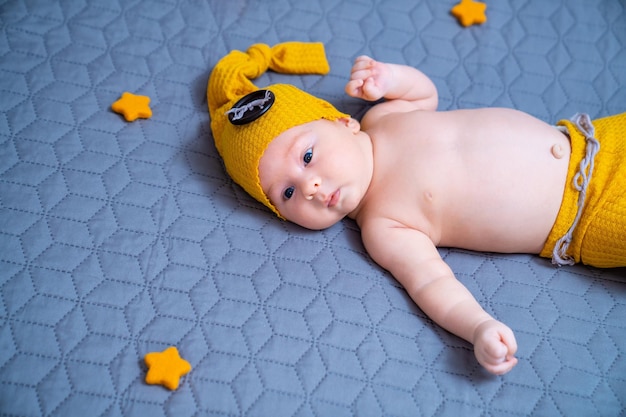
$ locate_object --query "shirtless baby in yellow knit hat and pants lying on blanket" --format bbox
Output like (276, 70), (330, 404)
(207, 43), (626, 374)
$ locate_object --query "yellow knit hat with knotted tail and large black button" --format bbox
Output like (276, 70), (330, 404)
(207, 42), (349, 218)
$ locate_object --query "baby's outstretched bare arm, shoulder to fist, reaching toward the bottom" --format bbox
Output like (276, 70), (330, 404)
(361, 224), (517, 375)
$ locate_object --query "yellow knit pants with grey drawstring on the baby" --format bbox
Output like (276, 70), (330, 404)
(540, 113), (626, 268)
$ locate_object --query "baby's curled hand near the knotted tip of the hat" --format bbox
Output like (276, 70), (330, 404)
(346, 55), (391, 101)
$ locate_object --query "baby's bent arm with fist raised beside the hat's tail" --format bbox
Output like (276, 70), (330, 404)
(346, 56), (438, 111)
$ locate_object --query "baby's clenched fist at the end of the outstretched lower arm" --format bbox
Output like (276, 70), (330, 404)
(474, 320), (517, 375)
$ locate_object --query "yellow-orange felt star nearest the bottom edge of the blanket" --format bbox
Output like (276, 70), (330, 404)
(144, 346), (191, 390)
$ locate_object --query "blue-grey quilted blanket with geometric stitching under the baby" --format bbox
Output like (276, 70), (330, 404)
(0, 0), (626, 417)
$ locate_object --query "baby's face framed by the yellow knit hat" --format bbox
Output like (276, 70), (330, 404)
(259, 119), (372, 230)
